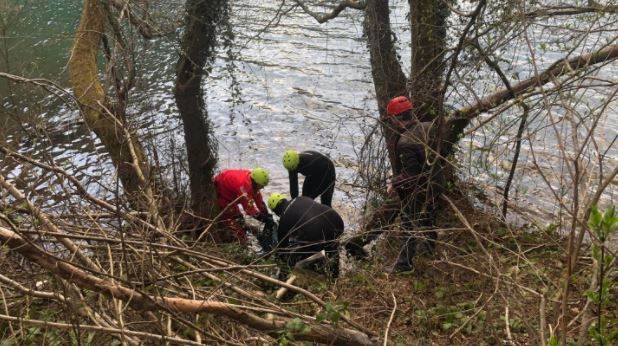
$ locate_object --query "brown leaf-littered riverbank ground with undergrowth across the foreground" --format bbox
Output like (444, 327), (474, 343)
(0, 189), (618, 345)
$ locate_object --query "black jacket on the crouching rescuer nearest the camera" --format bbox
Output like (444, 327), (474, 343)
(277, 196), (344, 249)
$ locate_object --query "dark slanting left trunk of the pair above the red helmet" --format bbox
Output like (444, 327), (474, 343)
(363, 0), (407, 173)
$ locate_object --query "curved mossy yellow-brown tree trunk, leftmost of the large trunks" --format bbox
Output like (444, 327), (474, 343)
(69, 0), (149, 199)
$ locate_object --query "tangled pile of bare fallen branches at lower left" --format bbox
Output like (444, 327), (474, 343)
(0, 148), (375, 344)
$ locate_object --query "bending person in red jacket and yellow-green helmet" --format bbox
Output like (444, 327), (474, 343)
(213, 167), (276, 243)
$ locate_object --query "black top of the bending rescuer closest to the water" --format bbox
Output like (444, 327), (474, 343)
(289, 150), (335, 198)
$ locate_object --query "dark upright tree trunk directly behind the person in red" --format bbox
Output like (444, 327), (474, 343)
(174, 0), (227, 222)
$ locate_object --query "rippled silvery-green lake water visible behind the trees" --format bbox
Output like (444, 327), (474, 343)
(0, 1), (618, 232)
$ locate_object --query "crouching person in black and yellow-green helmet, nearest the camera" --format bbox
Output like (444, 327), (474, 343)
(267, 193), (344, 277)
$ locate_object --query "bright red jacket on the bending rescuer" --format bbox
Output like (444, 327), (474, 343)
(214, 169), (268, 216)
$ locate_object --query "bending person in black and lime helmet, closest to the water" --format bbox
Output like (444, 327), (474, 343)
(283, 149), (337, 207)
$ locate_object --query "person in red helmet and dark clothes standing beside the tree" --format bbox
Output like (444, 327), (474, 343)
(346, 96), (441, 271)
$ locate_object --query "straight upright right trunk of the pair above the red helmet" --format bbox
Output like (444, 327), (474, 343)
(409, 0), (448, 121)
